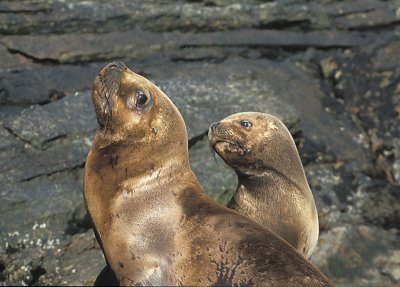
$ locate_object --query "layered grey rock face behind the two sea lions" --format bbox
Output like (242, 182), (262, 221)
(0, 0), (400, 286)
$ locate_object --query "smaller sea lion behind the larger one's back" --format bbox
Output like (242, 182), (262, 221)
(208, 112), (319, 258)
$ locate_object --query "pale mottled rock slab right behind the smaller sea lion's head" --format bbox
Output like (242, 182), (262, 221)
(154, 58), (365, 166)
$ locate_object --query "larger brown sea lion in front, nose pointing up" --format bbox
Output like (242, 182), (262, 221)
(84, 63), (332, 286)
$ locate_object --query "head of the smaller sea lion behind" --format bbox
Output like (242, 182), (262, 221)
(208, 112), (295, 176)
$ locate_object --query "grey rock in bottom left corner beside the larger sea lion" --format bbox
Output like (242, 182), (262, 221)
(1, 232), (105, 286)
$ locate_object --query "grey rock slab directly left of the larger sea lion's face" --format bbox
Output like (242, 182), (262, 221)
(4, 92), (97, 148)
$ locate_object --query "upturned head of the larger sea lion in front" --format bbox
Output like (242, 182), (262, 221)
(92, 62), (187, 150)
